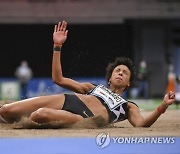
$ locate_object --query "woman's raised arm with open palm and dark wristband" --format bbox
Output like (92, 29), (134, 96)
(52, 21), (95, 94)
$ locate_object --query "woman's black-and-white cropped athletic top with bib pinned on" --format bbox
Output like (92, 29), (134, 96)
(88, 84), (135, 123)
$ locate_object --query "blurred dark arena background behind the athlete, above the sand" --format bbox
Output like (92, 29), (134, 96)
(0, 0), (180, 109)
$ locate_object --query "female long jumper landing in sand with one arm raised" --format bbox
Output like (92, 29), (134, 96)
(0, 21), (175, 127)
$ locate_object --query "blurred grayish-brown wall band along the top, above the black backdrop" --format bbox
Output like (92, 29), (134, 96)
(0, 0), (180, 24)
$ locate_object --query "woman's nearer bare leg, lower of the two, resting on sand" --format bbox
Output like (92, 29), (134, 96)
(29, 108), (84, 124)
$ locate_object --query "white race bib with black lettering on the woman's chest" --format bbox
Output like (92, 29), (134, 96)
(91, 85), (127, 111)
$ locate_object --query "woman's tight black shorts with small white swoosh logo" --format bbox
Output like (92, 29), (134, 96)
(62, 94), (94, 118)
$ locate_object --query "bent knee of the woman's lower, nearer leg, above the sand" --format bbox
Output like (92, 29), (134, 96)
(29, 108), (49, 123)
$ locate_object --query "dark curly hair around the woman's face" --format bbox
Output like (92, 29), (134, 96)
(106, 57), (135, 84)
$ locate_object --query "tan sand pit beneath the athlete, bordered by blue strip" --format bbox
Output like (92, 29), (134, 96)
(0, 110), (180, 138)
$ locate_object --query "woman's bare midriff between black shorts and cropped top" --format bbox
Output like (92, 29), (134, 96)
(76, 94), (108, 120)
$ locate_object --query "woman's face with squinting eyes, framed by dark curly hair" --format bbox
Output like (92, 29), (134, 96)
(109, 65), (131, 88)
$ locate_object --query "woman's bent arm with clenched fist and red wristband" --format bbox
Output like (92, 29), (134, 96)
(128, 92), (175, 127)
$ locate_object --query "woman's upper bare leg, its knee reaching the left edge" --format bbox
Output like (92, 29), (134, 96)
(0, 94), (65, 122)
